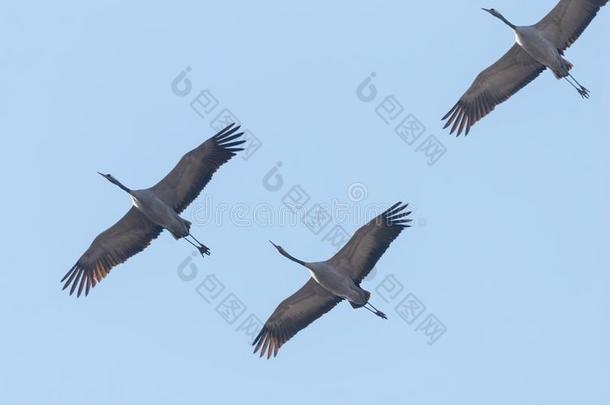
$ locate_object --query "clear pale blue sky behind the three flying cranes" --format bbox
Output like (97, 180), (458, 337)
(0, 0), (610, 405)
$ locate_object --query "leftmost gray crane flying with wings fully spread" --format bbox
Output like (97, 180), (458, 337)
(61, 124), (245, 297)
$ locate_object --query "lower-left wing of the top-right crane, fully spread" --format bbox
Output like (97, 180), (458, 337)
(442, 44), (546, 136)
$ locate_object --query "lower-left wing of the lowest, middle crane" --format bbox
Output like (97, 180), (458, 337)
(252, 278), (343, 358)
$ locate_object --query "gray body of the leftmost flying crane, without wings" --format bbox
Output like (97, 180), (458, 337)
(130, 189), (191, 239)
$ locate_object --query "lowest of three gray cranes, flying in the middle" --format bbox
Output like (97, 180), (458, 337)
(252, 202), (411, 358)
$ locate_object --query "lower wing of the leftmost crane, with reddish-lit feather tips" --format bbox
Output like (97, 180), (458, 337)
(61, 207), (163, 297)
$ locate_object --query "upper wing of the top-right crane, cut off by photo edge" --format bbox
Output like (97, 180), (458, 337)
(534, 0), (608, 52)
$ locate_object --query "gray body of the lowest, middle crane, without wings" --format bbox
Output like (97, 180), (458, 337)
(305, 262), (371, 307)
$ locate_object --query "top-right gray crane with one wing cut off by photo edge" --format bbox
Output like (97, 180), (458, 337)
(442, 0), (608, 136)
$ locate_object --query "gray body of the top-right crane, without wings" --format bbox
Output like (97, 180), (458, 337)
(514, 26), (572, 79)
